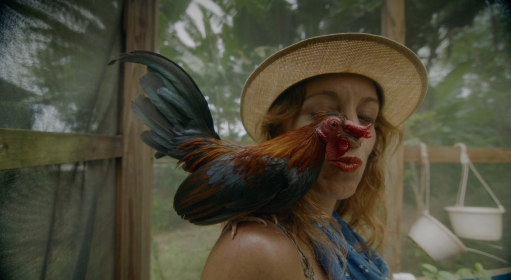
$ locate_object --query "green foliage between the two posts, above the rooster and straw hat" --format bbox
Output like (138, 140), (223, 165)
(158, 0), (381, 142)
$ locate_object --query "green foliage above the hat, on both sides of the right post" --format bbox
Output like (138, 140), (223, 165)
(159, 0), (511, 147)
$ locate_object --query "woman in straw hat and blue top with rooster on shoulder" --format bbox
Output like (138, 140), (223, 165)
(202, 34), (427, 280)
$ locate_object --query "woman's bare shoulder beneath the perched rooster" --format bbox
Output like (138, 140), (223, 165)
(201, 221), (304, 280)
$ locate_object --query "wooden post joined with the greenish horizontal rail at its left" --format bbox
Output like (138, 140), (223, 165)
(0, 0), (158, 279)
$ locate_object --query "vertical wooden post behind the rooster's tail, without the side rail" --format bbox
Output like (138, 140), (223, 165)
(116, 0), (158, 279)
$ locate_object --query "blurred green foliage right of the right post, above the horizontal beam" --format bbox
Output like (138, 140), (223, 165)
(405, 1), (511, 147)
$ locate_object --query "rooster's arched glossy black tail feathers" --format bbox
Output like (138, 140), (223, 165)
(109, 51), (220, 159)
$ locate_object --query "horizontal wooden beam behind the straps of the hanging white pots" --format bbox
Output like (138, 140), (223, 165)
(404, 146), (511, 163)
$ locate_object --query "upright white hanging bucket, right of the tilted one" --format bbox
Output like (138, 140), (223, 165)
(445, 206), (506, 241)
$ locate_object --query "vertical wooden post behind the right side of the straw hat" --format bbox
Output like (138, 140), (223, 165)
(382, 0), (405, 273)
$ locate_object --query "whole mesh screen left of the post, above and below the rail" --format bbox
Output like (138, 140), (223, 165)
(0, 1), (122, 279)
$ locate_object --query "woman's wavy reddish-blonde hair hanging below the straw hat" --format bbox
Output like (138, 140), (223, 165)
(260, 74), (402, 276)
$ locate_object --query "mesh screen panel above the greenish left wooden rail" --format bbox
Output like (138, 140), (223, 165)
(0, 1), (121, 135)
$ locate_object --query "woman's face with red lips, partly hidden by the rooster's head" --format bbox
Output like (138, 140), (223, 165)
(282, 74), (380, 205)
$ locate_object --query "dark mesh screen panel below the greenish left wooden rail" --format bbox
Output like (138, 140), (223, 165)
(0, 160), (116, 279)
